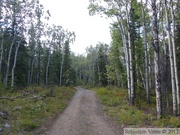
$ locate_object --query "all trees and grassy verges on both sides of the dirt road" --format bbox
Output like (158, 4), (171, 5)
(0, 0), (180, 132)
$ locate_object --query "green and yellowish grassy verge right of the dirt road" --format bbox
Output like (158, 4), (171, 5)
(93, 87), (180, 128)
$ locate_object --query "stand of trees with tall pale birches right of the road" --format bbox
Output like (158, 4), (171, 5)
(71, 0), (180, 118)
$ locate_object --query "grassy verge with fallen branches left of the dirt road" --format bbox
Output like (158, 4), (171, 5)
(0, 87), (76, 135)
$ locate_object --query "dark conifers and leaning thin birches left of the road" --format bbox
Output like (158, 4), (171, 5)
(0, 0), (75, 90)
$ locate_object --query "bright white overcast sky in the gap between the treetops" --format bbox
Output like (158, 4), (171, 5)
(40, 0), (111, 54)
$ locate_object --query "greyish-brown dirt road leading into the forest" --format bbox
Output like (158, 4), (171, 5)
(48, 87), (121, 135)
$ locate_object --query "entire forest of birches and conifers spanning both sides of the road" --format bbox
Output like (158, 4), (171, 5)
(0, 0), (180, 133)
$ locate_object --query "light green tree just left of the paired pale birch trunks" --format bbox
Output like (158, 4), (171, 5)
(106, 26), (126, 87)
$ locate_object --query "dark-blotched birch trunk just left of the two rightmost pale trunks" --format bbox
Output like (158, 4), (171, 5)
(151, 0), (162, 119)
